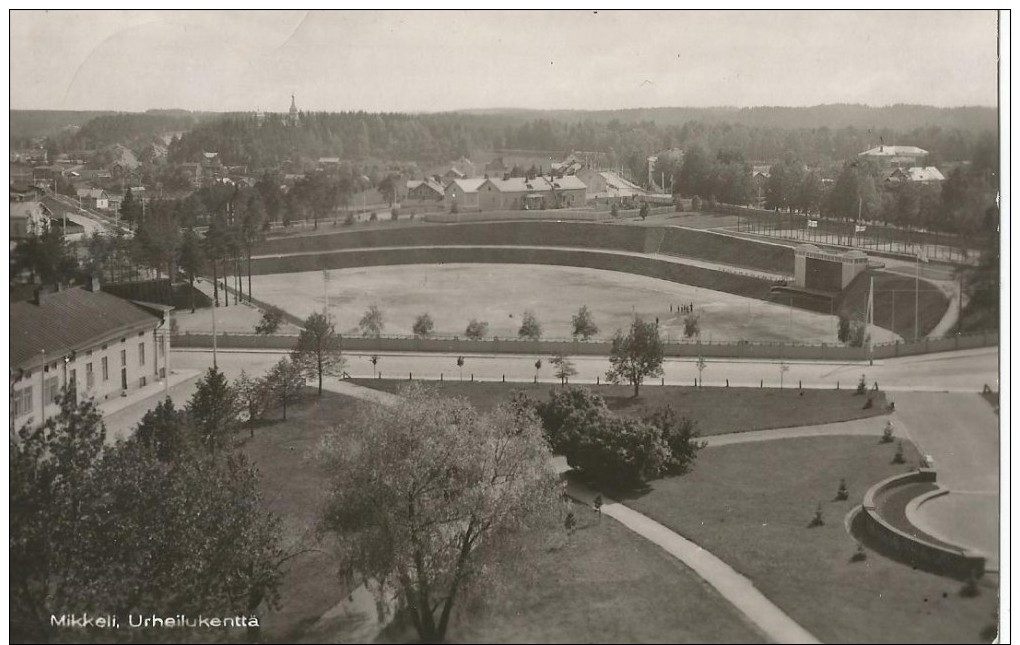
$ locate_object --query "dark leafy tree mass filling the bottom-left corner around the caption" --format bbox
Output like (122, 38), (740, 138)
(9, 385), (286, 642)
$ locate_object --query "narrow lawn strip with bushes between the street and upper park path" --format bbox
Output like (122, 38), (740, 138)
(354, 379), (885, 437)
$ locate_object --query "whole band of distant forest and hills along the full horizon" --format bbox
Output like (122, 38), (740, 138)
(11, 105), (998, 177)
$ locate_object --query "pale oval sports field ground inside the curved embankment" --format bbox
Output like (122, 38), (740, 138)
(253, 263), (901, 343)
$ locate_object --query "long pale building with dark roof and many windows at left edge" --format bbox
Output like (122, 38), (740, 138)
(9, 281), (171, 428)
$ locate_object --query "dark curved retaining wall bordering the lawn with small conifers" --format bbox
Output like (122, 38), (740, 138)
(861, 468), (985, 579)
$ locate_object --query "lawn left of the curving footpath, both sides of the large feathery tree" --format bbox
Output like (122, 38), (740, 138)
(236, 388), (761, 642)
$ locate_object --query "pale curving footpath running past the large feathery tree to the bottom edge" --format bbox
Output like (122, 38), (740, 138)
(322, 378), (821, 643)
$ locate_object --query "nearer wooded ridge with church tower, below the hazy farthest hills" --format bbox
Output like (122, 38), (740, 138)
(150, 112), (993, 182)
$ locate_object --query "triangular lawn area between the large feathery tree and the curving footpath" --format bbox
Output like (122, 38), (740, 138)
(449, 508), (764, 643)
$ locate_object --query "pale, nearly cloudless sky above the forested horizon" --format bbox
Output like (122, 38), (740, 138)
(10, 10), (998, 112)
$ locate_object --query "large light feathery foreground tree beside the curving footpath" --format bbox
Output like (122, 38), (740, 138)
(321, 385), (558, 643)
